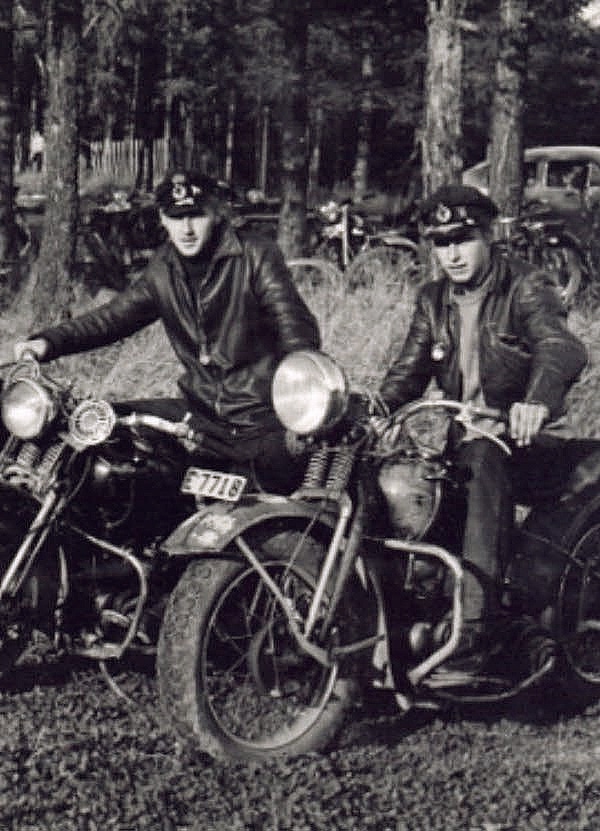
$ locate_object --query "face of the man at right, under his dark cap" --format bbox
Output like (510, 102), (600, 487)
(431, 228), (490, 285)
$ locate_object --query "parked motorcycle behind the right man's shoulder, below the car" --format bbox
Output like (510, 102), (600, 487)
(499, 205), (595, 309)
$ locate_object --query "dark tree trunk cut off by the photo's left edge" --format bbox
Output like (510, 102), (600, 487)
(0, 2), (19, 306)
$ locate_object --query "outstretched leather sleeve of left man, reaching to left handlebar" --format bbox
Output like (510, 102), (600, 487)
(31, 277), (159, 361)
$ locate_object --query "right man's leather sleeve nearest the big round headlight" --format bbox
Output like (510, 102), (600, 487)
(379, 284), (433, 410)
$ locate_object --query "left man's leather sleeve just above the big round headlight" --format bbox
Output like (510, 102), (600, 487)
(253, 244), (321, 356)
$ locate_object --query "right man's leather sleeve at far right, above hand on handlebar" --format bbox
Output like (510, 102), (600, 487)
(517, 271), (587, 418)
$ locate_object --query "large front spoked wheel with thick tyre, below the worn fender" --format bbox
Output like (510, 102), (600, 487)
(158, 532), (354, 760)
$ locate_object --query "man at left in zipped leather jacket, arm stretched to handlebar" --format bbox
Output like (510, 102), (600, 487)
(15, 170), (320, 487)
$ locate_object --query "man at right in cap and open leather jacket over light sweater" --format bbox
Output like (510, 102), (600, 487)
(380, 185), (587, 668)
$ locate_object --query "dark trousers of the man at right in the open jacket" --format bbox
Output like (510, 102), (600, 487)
(455, 434), (600, 620)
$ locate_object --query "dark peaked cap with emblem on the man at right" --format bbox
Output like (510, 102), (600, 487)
(419, 185), (498, 236)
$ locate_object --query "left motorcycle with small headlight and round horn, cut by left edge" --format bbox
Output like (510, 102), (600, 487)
(0, 355), (258, 678)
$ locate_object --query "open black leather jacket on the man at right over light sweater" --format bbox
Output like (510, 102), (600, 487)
(380, 252), (587, 418)
